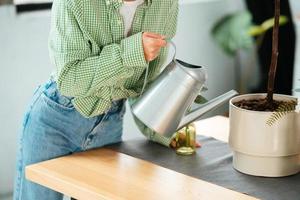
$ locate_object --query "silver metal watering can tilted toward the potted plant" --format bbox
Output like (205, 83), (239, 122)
(131, 42), (237, 137)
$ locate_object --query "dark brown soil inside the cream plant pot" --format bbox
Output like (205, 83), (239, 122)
(233, 98), (297, 112)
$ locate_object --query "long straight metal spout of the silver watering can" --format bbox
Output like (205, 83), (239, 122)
(177, 90), (238, 130)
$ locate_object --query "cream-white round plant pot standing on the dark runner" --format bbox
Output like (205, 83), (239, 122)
(229, 94), (300, 177)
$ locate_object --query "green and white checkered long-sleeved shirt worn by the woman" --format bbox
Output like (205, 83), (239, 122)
(49, 0), (178, 147)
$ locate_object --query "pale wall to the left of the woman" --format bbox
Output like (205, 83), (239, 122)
(0, 6), (51, 196)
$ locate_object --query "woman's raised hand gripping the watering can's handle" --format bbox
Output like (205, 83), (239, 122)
(143, 32), (167, 62)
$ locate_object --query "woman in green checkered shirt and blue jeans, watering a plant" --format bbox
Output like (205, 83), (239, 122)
(14, 0), (178, 200)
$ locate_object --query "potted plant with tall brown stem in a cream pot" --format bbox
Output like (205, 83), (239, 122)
(229, 0), (300, 177)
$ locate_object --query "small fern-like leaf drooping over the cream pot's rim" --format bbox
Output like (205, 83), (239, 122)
(267, 101), (297, 126)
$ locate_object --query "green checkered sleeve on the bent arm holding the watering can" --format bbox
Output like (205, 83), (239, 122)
(49, 0), (148, 97)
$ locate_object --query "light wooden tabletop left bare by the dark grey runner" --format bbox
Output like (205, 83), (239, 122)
(26, 117), (255, 200)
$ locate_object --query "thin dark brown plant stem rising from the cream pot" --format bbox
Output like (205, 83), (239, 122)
(267, 0), (280, 107)
